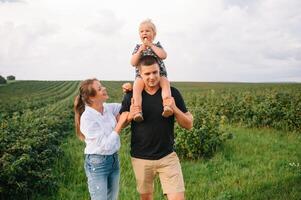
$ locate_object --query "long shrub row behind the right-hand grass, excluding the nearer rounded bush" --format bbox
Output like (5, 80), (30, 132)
(183, 88), (301, 132)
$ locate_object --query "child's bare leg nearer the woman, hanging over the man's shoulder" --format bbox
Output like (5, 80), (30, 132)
(133, 77), (144, 122)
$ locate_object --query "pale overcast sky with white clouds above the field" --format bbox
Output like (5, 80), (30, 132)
(0, 0), (301, 82)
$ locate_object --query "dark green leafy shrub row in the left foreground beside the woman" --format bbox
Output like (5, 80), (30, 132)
(0, 82), (78, 199)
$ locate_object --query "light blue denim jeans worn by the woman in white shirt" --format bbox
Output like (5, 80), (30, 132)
(85, 152), (120, 200)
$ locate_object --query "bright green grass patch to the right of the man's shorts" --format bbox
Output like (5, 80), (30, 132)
(182, 128), (301, 200)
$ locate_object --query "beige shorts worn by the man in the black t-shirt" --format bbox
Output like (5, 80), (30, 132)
(131, 152), (185, 194)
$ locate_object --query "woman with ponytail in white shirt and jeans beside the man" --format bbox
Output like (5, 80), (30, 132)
(74, 79), (128, 200)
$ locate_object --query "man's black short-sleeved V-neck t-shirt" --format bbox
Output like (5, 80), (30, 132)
(120, 87), (187, 160)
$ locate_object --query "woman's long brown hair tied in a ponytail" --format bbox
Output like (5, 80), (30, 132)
(73, 78), (98, 140)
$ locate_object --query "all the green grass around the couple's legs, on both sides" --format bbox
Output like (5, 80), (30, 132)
(35, 127), (301, 200)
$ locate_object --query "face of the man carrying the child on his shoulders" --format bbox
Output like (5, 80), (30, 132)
(140, 63), (160, 87)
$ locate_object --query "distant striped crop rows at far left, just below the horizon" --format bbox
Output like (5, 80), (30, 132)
(0, 81), (77, 119)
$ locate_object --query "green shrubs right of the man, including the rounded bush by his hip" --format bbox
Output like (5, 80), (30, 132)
(175, 84), (301, 159)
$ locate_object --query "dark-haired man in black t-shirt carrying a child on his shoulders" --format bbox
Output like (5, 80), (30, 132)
(120, 56), (193, 200)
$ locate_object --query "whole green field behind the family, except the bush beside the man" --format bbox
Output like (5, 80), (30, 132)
(0, 81), (301, 200)
